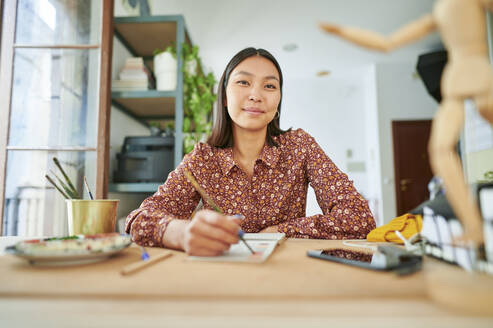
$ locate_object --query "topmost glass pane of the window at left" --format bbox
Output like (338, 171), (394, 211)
(15, 0), (102, 45)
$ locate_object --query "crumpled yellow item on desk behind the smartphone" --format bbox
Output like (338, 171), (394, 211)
(366, 213), (423, 244)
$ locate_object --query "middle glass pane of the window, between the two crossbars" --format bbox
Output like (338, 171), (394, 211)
(9, 49), (99, 147)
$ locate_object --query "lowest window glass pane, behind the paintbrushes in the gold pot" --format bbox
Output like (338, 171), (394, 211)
(3, 151), (96, 237)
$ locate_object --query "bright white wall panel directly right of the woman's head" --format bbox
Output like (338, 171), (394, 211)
(281, 68), (367, 215)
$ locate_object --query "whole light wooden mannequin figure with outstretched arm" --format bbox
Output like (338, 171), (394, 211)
(320, 0), (493, 244)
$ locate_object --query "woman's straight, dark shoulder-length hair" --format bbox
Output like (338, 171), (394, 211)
(207, 47), (291, 148)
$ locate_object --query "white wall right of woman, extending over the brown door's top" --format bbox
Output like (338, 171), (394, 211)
(281, 61), (437, 225)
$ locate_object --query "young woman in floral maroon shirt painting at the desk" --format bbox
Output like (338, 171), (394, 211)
(126, 48), (375, 256)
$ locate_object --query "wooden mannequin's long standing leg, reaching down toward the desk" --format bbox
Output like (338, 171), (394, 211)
(428, 98), (483, 244)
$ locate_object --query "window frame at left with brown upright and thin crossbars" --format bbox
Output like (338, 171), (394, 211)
(0, 0), (114, 236)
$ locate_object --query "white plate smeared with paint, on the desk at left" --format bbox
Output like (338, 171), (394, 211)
(5, 234), (132, 266)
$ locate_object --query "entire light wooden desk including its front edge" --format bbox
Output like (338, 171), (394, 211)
(0, 239), (493, 327)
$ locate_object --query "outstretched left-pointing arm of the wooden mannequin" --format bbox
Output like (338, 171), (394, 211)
(320, 14), (436, 52)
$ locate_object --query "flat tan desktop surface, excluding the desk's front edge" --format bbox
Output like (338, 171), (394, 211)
(0, 239), (426, 299)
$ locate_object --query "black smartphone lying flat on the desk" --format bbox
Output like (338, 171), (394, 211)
(307, 245), (421, 274)
